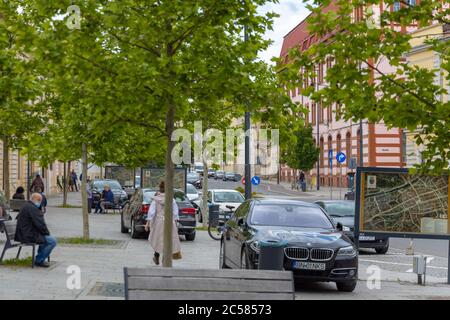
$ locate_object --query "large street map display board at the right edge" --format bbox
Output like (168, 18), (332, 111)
(356, 168), (450, 238)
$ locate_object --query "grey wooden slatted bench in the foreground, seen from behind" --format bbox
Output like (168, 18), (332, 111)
(124, 268), (295, 300)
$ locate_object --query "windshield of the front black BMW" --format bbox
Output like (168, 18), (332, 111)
(250, 204), (333, 229)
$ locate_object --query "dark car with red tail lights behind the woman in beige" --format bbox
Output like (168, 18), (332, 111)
(120, 189), (197, 241)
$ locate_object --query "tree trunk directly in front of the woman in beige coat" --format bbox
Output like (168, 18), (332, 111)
(163, 102), (175, 268)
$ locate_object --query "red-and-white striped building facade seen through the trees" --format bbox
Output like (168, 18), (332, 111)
(280, 3), (417, 187)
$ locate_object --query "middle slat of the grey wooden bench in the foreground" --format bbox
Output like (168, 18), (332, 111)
(128, 277), (293, 293)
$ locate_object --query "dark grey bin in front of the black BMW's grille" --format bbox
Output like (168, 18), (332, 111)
(258, 240), (287, 270)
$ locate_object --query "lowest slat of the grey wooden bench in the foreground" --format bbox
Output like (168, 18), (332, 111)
(129, 290), (294, 301)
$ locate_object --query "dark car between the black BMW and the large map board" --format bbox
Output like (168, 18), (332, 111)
(315, 200), (389, 254)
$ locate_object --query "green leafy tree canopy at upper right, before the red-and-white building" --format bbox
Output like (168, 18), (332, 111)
(280, 0), (450, 173)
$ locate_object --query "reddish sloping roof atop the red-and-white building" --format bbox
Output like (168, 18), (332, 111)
(280, 1), (337, 58)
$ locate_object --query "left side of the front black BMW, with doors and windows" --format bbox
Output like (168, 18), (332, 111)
(225, 201), (250, 268)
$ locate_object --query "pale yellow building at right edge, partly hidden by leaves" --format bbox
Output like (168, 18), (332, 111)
(403, 24), (450, 167)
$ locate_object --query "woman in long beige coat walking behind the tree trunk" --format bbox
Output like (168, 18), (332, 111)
(145, 181), (181, 265)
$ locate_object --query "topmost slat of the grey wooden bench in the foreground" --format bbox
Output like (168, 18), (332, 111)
(127, 268), (292, 280)
